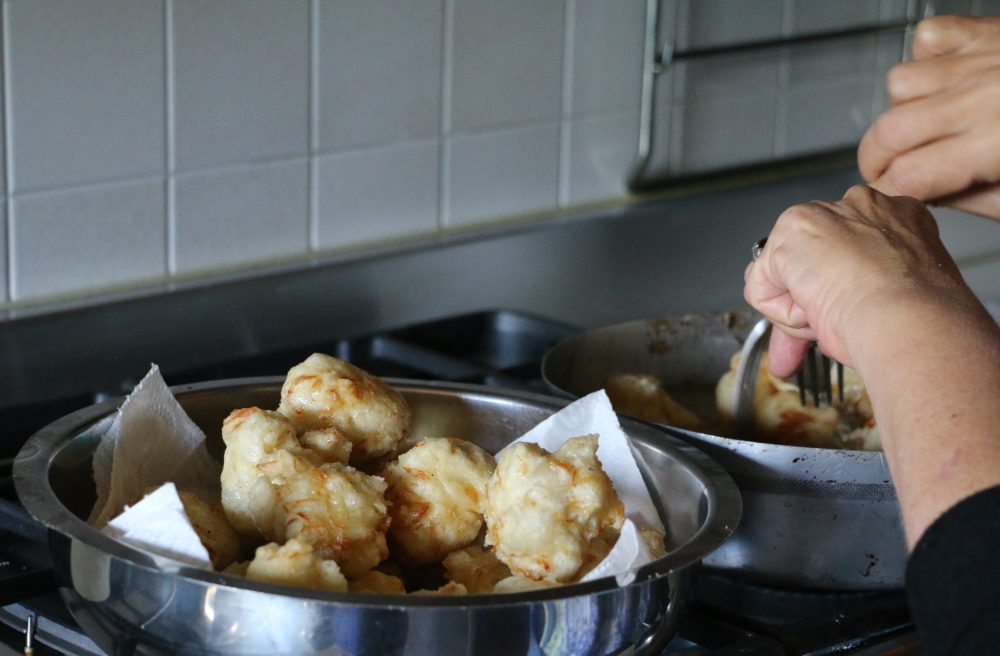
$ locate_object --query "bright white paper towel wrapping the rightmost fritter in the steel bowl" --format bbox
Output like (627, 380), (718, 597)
(508, 390), (663, 585)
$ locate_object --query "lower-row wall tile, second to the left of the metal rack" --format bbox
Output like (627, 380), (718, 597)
(443, 124), (559, 226)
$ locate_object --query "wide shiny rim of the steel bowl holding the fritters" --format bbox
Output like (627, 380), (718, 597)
(13, 376), (742, 608)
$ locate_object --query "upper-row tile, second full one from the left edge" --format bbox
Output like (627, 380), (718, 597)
(170, 0), (309, 171)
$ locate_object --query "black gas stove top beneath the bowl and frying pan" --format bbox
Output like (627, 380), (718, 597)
(0, 310), (919, 655)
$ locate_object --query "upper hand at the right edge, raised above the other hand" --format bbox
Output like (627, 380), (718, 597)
(858, 16), (1000, 219)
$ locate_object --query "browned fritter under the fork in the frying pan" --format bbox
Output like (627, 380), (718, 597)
(715, 353), (877, 448)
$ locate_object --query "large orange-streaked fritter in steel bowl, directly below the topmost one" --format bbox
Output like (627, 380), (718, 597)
(260, 451), (389, 576)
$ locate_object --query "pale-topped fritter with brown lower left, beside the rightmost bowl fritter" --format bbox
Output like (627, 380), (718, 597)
(381, 437), (496, 565)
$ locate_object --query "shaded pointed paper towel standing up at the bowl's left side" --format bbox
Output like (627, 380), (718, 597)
(87, 365), (222, 528)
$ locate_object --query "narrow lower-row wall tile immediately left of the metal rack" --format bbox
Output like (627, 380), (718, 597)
(566, 114), (639, 204)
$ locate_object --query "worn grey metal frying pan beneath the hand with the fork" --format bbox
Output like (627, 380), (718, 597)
(542, 311), (906, 590)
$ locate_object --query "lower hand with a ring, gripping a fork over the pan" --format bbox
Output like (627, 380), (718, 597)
(744, 185), (974, 377)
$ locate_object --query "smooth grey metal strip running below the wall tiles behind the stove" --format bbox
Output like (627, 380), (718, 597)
(0, 166), (858, 407)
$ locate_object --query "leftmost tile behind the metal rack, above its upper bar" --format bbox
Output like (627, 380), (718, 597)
(674, 0), (782, 50)
